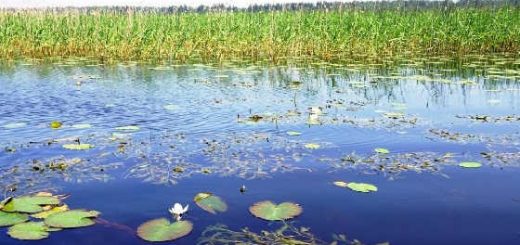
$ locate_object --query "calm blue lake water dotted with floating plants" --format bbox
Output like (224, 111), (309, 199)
(0, 56), (520, 244)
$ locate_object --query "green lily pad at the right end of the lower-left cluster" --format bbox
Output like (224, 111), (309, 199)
(44, 209), (100, 228)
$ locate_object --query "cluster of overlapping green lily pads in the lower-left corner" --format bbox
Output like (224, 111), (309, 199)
(0, 192), (100, 240)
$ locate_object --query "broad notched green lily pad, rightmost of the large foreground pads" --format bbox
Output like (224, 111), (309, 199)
(249, 201), (303, 221)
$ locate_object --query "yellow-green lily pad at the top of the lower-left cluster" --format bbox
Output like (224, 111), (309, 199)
(2, 196), (60, 213)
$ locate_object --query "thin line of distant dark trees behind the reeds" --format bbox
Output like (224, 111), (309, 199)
(3, 0), (520, 13)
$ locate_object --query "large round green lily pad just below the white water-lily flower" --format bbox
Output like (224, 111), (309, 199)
(137, 218), (193, 242)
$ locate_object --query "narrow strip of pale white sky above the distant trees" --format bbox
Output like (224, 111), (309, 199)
(0, 0), (366, 8)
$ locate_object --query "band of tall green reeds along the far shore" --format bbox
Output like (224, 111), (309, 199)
(0, 1), (520, 63)
